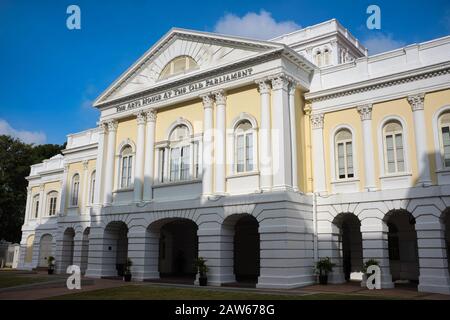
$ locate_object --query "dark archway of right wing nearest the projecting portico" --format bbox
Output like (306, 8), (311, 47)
(333, 213), (363, 281)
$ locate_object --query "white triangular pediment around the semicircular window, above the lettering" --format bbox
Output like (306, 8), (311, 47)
(94, 29), (282, 106)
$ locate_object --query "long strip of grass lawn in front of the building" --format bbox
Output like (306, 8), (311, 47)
(47, 285), (384, 300)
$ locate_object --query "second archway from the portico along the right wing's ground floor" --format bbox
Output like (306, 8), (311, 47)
(386, 210), (419, 285)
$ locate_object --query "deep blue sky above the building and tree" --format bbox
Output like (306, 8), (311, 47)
(0, 0), (450, 143)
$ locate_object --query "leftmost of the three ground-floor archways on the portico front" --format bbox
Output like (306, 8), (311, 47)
(103, 221), (128, 277)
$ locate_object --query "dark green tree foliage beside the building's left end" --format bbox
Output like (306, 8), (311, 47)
(0, 135), (65, 242)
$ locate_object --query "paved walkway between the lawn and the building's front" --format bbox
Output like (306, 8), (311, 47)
(0, 271), (450, 300)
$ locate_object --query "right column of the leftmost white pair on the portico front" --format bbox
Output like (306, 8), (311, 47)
(103, 120), (117, 206)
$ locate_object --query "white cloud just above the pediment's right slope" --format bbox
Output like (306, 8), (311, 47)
(214, 10), (301, 40)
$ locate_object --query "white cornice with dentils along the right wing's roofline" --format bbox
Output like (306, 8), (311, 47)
(305, 62), (450, 103)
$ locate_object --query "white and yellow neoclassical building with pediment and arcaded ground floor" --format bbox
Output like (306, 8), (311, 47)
(20, 20), (450, 294)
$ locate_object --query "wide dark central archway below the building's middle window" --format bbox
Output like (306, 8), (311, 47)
(157, 219), (198, 282)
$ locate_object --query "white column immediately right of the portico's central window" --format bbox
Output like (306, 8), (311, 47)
(201, 95), (213, 195)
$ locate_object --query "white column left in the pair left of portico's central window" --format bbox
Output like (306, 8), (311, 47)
(133, 111), (145, 202)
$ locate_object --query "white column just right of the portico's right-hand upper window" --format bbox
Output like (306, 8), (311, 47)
(256, 80), (272, 191)
